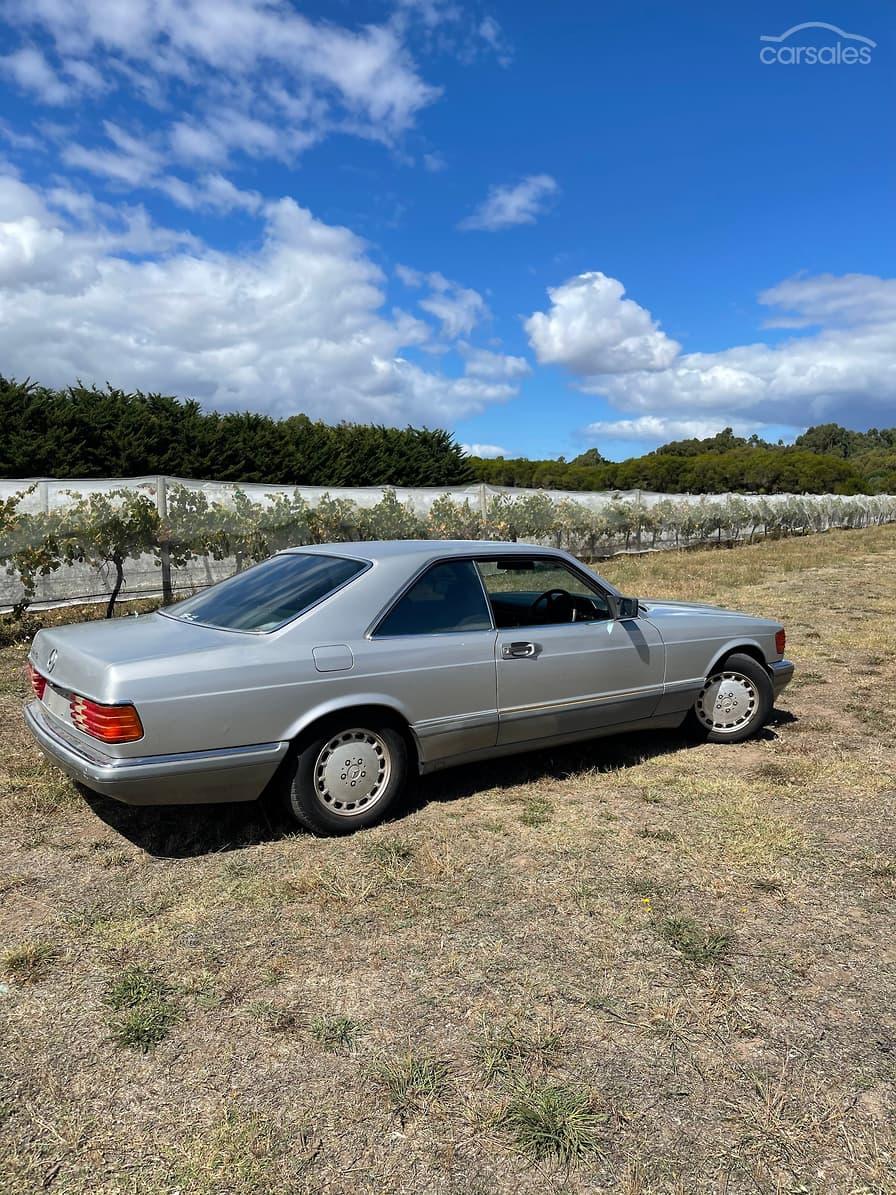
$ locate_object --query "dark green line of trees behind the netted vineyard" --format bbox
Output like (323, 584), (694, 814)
(0, 376), (896, 495)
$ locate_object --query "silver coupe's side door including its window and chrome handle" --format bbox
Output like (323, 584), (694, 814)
(478, 557), (665, 746)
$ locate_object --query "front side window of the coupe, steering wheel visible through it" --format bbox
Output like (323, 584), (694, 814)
(478, 557), (613, 629)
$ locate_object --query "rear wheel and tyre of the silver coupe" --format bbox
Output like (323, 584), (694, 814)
(286, 716), (407, 837)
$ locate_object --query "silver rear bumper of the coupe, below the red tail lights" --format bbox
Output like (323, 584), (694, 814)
(25, 701), (289, 805)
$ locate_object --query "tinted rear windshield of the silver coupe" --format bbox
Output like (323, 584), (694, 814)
(164, 552), (367, 631)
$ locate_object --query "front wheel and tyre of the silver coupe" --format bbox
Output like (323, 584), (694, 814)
(689, 652), (774, 743)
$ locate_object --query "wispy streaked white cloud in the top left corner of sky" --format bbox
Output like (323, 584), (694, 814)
(2, 0), (440, 195)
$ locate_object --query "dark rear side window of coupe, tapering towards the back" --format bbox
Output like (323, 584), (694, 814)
(374, 560), (491, 638)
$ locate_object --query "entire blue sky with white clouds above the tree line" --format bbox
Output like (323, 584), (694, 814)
(0, 0), (896, 458)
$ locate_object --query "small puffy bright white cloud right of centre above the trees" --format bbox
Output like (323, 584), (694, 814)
(526, 271), (679, 376)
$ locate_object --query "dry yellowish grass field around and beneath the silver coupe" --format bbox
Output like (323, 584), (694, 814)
(0, 527), (896, 1195)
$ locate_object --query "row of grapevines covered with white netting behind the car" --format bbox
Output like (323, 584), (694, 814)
(0, 477), (896, 609)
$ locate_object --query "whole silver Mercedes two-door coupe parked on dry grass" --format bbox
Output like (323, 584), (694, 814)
(25, 540), (793, 834)
